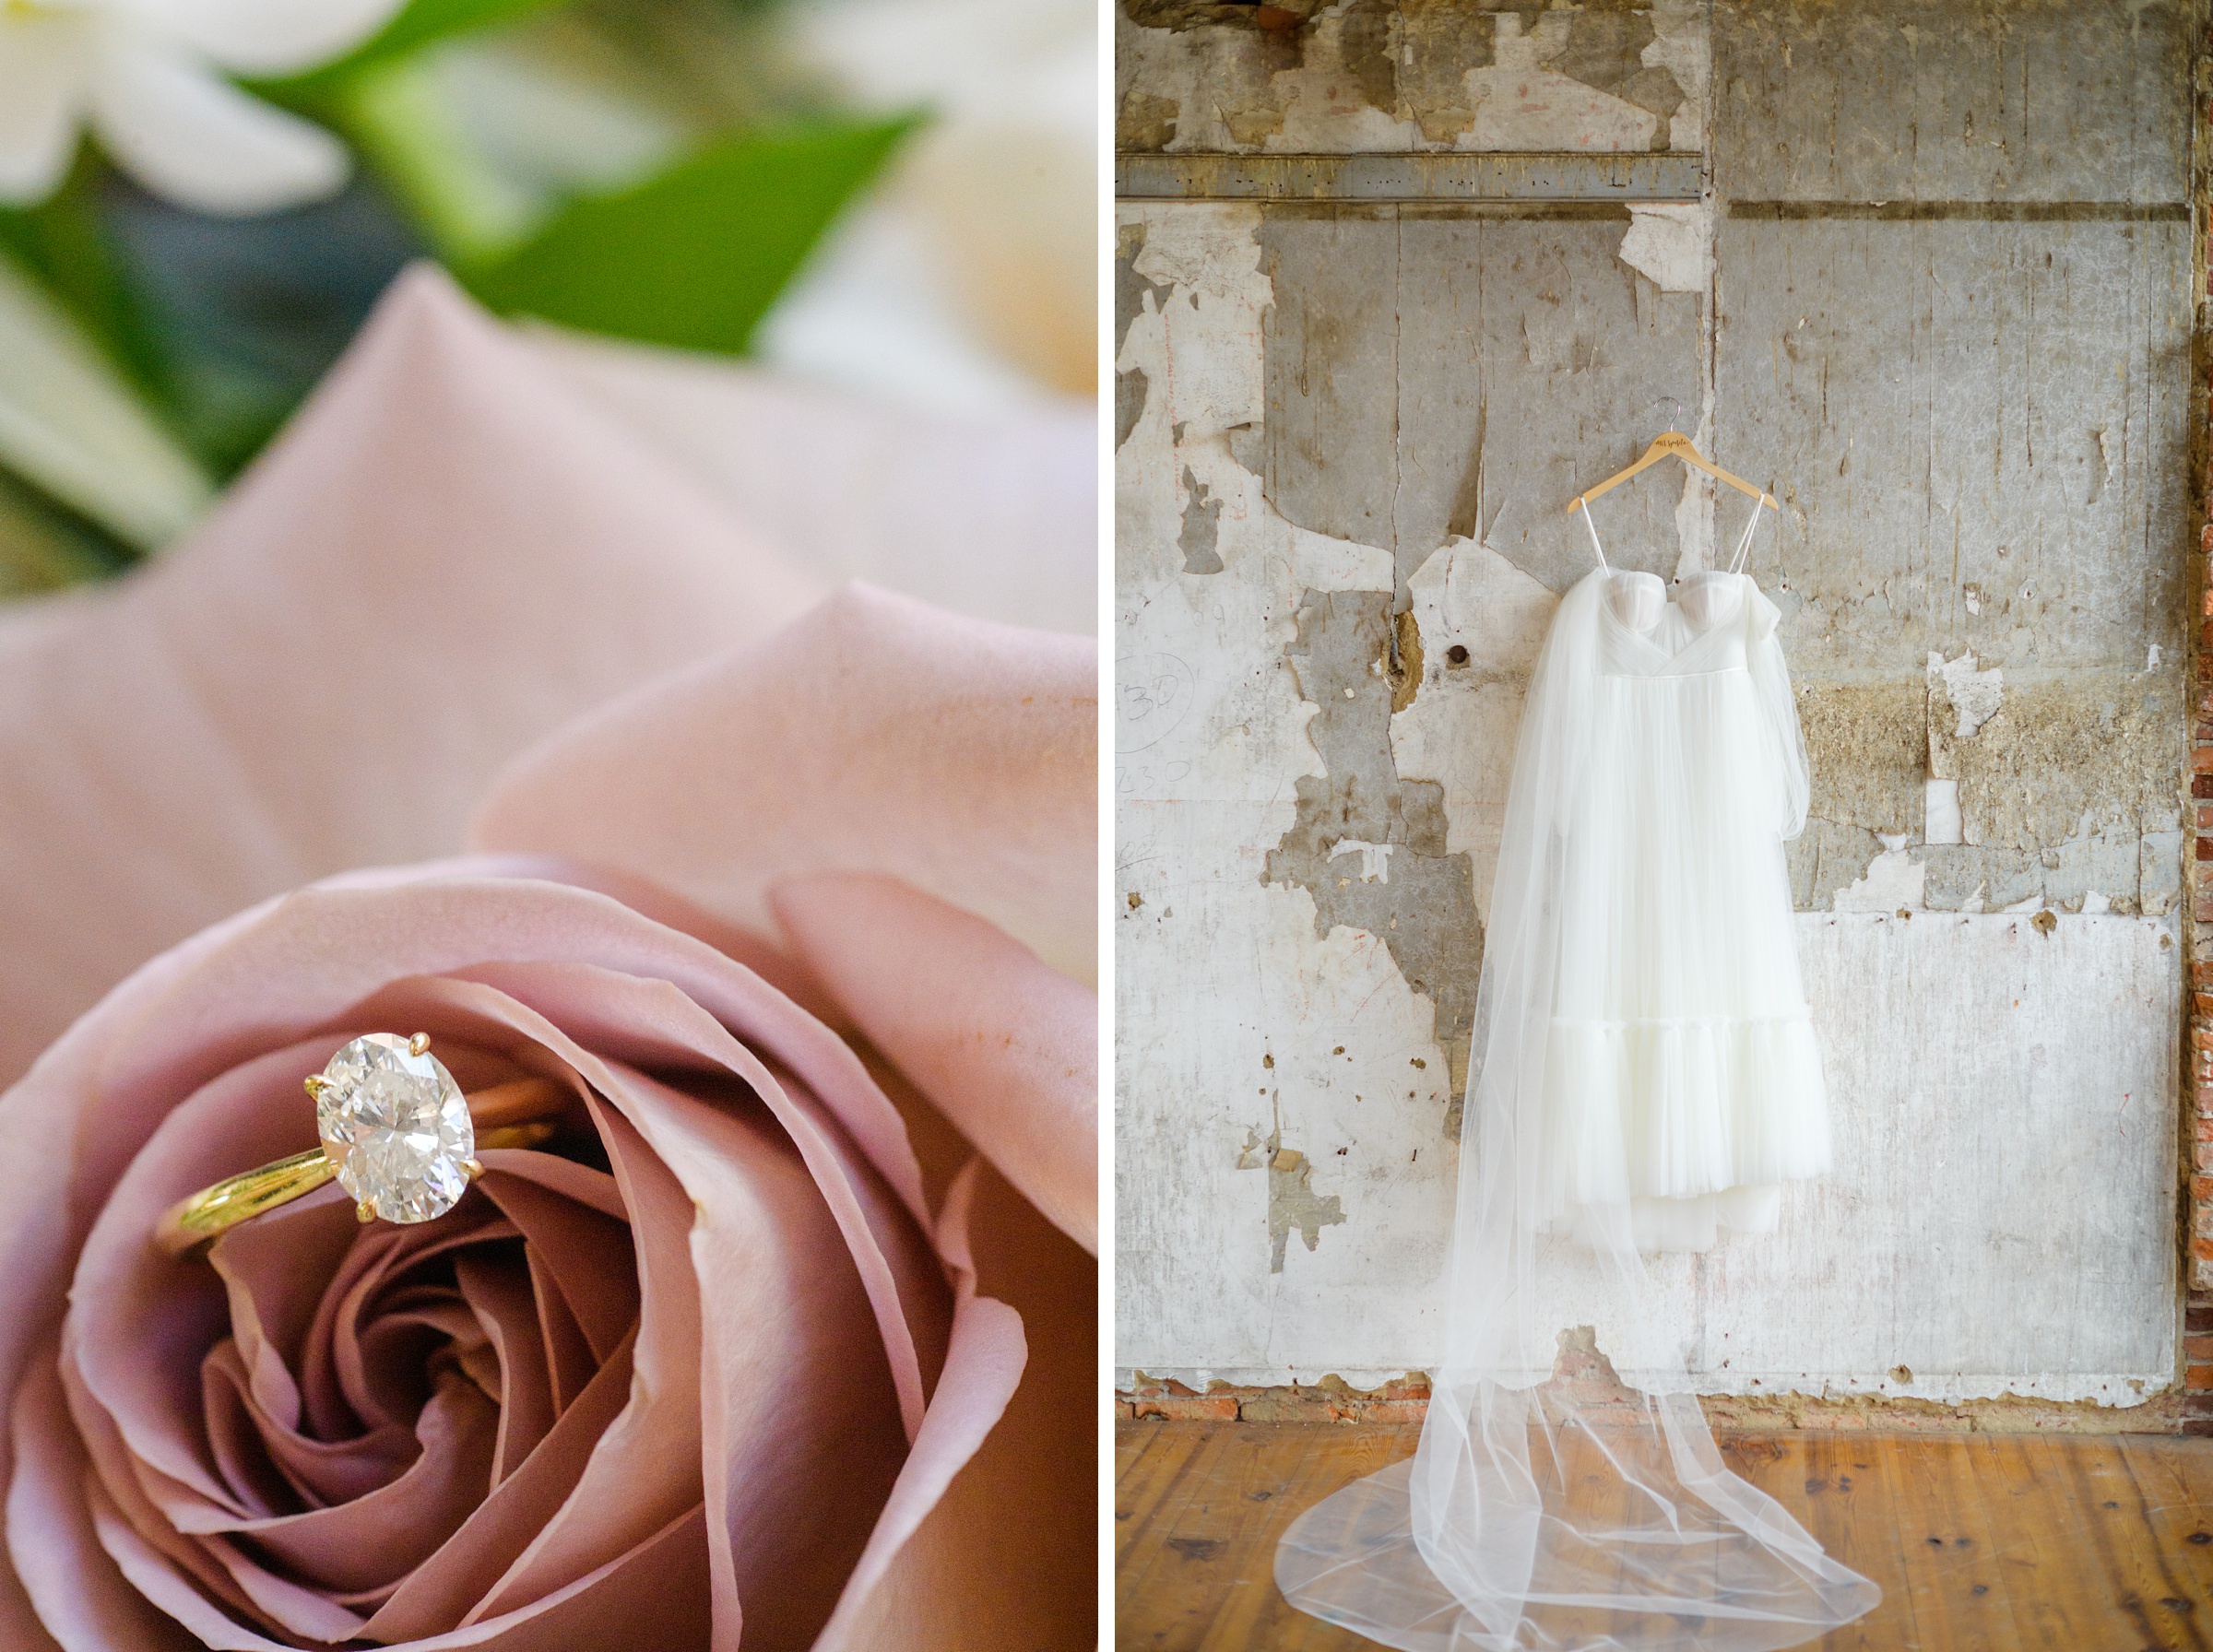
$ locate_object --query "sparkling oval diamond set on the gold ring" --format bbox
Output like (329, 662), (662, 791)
(314, 1032), (476, 1221)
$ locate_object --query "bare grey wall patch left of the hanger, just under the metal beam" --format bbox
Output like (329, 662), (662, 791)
(1249, 206), (1699, 606)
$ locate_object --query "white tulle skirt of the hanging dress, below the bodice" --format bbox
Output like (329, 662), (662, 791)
(1538, 667), (1830, 1249)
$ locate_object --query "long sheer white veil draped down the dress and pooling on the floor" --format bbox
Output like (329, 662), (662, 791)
(1277, 572), (1881, 1652)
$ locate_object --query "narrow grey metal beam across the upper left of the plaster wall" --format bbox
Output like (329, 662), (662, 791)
(1116, 153), (1704, 201)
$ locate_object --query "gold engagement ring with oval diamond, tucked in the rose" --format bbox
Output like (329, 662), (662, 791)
(153, 1032), (566, 1257)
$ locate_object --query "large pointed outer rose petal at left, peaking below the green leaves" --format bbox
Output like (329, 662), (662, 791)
(0, 267), (819, 1081)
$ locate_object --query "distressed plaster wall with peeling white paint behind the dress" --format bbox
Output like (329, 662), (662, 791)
(1118, 0), (2195, 1404)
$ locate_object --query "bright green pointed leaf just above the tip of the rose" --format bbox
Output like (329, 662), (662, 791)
(463, 117), (918, 356)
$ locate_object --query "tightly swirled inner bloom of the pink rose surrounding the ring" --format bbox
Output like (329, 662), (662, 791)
(0, 869), (1023, 1647)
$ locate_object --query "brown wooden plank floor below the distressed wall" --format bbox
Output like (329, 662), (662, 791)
(1113, 1422), (2213, 1652)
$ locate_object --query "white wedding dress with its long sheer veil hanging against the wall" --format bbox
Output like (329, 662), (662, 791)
(1274, 506), (1881, 1652)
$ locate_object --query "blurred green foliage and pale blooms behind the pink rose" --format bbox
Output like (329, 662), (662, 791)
(0, 0), (1095, 595)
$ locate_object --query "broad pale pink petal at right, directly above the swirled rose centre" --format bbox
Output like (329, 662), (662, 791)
(474, 586), (1097, 980)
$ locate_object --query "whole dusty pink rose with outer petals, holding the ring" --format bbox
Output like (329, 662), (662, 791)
(0, 277), (1097, 1652)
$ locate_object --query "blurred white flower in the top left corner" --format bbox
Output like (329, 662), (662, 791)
(0, 0), (400, 215)
